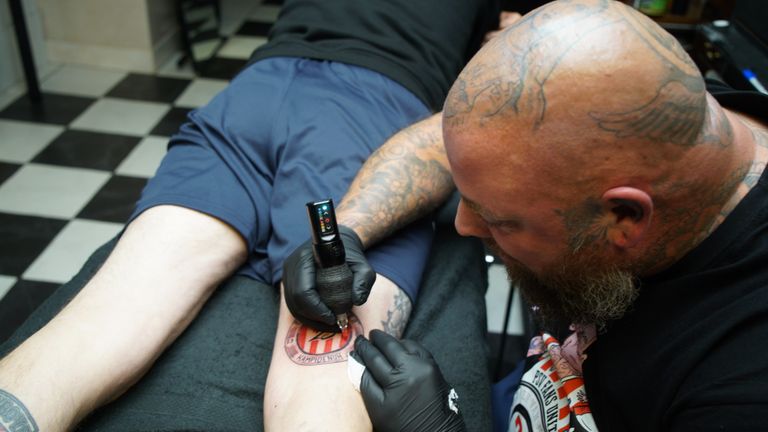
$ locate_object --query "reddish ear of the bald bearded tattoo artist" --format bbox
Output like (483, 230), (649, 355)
(601, 186), (653, 249)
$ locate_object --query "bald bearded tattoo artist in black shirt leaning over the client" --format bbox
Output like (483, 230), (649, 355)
(286, 0), (768, 431)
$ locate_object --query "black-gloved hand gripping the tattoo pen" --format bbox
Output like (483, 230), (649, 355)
(283, 225), (376, 332)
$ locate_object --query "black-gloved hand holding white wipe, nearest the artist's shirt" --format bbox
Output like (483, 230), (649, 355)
(353, 330), (466, 432)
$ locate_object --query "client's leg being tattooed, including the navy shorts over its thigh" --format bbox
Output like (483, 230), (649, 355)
(264, 61), (432, 431)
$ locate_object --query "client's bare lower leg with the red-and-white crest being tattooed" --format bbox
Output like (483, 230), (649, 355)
(264, 275), (411, 432)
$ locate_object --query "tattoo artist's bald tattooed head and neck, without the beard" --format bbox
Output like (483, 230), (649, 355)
(443, 0), (766, 317)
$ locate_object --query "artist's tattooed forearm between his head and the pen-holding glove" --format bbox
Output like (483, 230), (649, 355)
(337, 113), (453, 247)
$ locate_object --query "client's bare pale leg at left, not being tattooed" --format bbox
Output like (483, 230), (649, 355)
(0, 206), (246, 431)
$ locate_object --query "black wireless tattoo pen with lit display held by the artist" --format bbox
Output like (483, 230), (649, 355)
(307, 199), (353, 331)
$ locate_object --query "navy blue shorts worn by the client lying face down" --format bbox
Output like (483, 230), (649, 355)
(131, 57), (432, 300)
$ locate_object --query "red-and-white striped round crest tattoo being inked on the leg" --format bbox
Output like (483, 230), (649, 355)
(285, 314), (363, 366)
